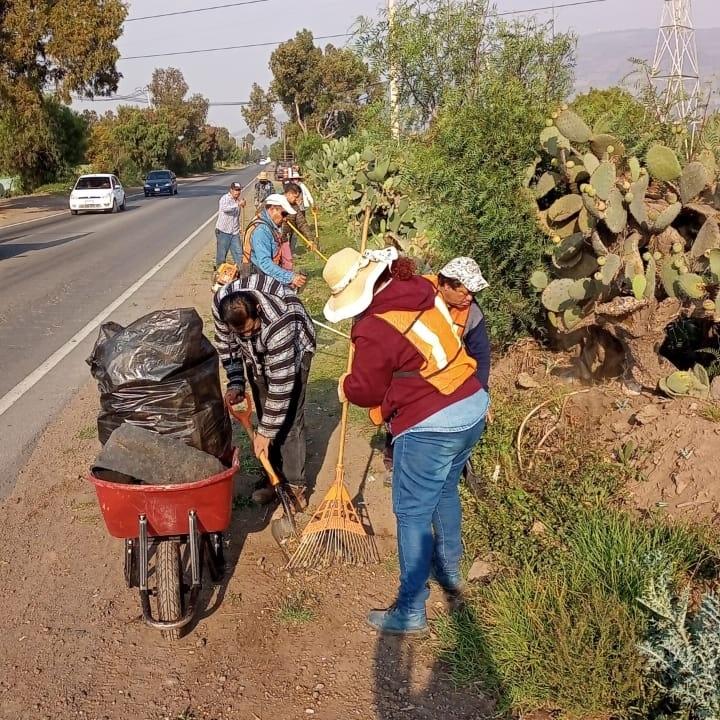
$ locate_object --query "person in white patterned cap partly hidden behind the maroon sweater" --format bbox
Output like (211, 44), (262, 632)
(383, 257), (490, 473)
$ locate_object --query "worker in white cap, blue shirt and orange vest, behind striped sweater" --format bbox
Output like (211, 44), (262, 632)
(242, 193), (307, 289)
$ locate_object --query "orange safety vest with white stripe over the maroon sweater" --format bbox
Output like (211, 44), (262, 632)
(370, 295), (477, 425)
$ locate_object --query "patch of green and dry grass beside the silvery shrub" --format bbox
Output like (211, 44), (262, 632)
(434, 391), (718, 718)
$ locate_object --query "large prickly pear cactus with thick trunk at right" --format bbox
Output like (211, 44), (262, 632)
(525, 106), (720, 388)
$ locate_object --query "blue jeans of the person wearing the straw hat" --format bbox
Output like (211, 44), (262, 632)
(392, 417), (485, 611)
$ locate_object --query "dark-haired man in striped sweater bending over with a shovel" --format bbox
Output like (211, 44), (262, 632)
(213, 273), (316, 505)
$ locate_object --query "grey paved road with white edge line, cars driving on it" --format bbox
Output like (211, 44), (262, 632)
(0, 167), (257, 497)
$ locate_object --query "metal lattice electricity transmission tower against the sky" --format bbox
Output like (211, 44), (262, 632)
(651, 0), (701, 128)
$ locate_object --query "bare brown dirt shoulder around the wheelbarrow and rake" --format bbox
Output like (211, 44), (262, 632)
(0, 240), (490, 720)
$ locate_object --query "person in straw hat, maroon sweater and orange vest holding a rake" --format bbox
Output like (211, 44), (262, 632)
(323, 247), (488, 634)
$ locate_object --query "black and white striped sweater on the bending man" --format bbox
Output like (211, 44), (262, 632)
(213, 274), (315, 439)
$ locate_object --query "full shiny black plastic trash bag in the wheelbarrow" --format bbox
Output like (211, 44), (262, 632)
(87, 308), (232, 462)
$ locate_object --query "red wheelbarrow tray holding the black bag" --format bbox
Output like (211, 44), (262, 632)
(88, 462), (237, 538)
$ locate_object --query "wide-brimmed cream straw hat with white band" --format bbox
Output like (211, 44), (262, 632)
(323, 247), (398, 322)
